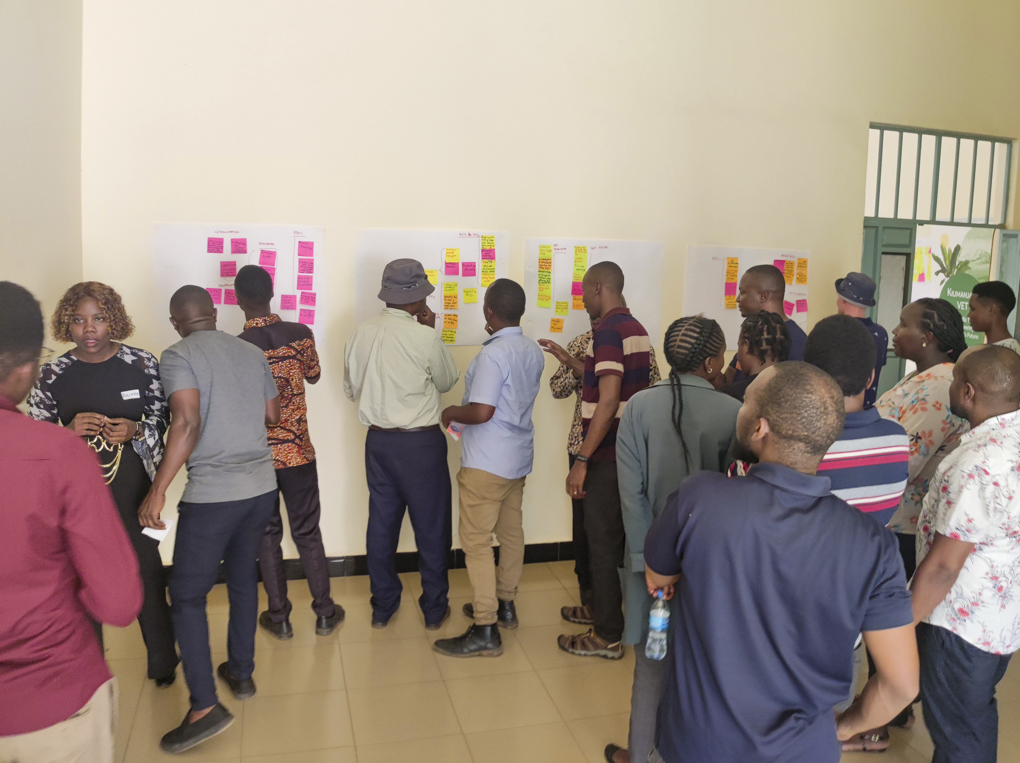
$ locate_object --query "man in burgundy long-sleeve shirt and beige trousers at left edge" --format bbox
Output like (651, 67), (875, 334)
(0, 282), (142, 763)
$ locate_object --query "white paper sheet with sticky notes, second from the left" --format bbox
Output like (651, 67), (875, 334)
(354, 230), (510, 345)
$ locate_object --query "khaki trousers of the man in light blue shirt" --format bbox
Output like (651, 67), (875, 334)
(457, 468), (526, 625)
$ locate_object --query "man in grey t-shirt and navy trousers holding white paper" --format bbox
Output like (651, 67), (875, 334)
(139, 286), (279, 753)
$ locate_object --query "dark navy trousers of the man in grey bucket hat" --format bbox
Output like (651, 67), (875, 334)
(365, 426), (453, 623)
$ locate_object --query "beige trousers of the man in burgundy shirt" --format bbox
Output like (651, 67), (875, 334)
(0, 678), (117, 763)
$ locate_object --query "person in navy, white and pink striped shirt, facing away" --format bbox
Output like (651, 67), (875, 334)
(804, 315), (910, 527)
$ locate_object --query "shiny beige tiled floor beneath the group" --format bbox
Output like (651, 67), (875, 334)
(106, 562), (1020, 763)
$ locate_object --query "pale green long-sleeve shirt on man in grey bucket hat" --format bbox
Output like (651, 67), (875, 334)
(344, 307), (458, 429)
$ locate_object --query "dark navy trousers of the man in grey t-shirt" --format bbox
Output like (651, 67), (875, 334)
(169, 491), (276, 710)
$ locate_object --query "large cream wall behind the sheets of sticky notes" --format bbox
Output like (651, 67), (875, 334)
(83, 0), (1020, 554)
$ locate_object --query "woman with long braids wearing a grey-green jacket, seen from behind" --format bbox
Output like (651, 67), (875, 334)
(606, 316), (741, 763)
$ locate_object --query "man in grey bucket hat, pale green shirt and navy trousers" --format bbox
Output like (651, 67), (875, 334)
(344, 259), (458, 630)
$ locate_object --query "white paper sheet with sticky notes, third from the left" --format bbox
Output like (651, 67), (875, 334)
(521, 239), (662, 347)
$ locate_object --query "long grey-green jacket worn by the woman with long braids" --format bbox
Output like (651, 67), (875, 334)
(616, 374), (741, 645)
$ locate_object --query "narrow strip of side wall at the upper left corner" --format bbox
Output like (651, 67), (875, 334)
(0, 0), (82, 316)
